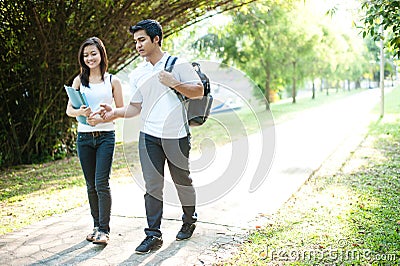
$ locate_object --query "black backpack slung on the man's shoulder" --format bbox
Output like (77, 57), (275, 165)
(164, 56), (213, 133)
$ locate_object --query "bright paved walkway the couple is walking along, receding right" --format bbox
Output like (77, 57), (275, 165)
(0, 90), (379, 265)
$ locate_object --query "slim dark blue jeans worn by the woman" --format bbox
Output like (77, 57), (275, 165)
(77, 131), (115, 233)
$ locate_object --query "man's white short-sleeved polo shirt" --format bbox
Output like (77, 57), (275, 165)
(129, 53), (201, 139)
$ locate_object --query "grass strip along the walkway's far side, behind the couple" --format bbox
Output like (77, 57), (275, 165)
(0, 87), (374, 235)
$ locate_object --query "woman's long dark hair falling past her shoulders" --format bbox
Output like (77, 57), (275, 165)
(78, 37), (108, 87)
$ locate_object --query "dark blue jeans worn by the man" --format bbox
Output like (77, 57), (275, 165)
(139, 132), (197, 236)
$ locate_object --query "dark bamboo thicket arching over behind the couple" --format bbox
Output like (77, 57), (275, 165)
(0, 0), (254, 166)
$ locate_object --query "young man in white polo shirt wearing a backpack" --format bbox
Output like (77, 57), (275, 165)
(97, 20), (203, 254)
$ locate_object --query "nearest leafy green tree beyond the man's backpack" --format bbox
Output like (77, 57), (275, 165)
(194, 1), (298, 108)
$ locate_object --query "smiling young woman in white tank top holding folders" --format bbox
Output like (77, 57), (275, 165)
(66, 37), (123, 245)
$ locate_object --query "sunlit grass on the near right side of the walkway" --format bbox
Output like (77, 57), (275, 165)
(218, 88), (400, 265)
